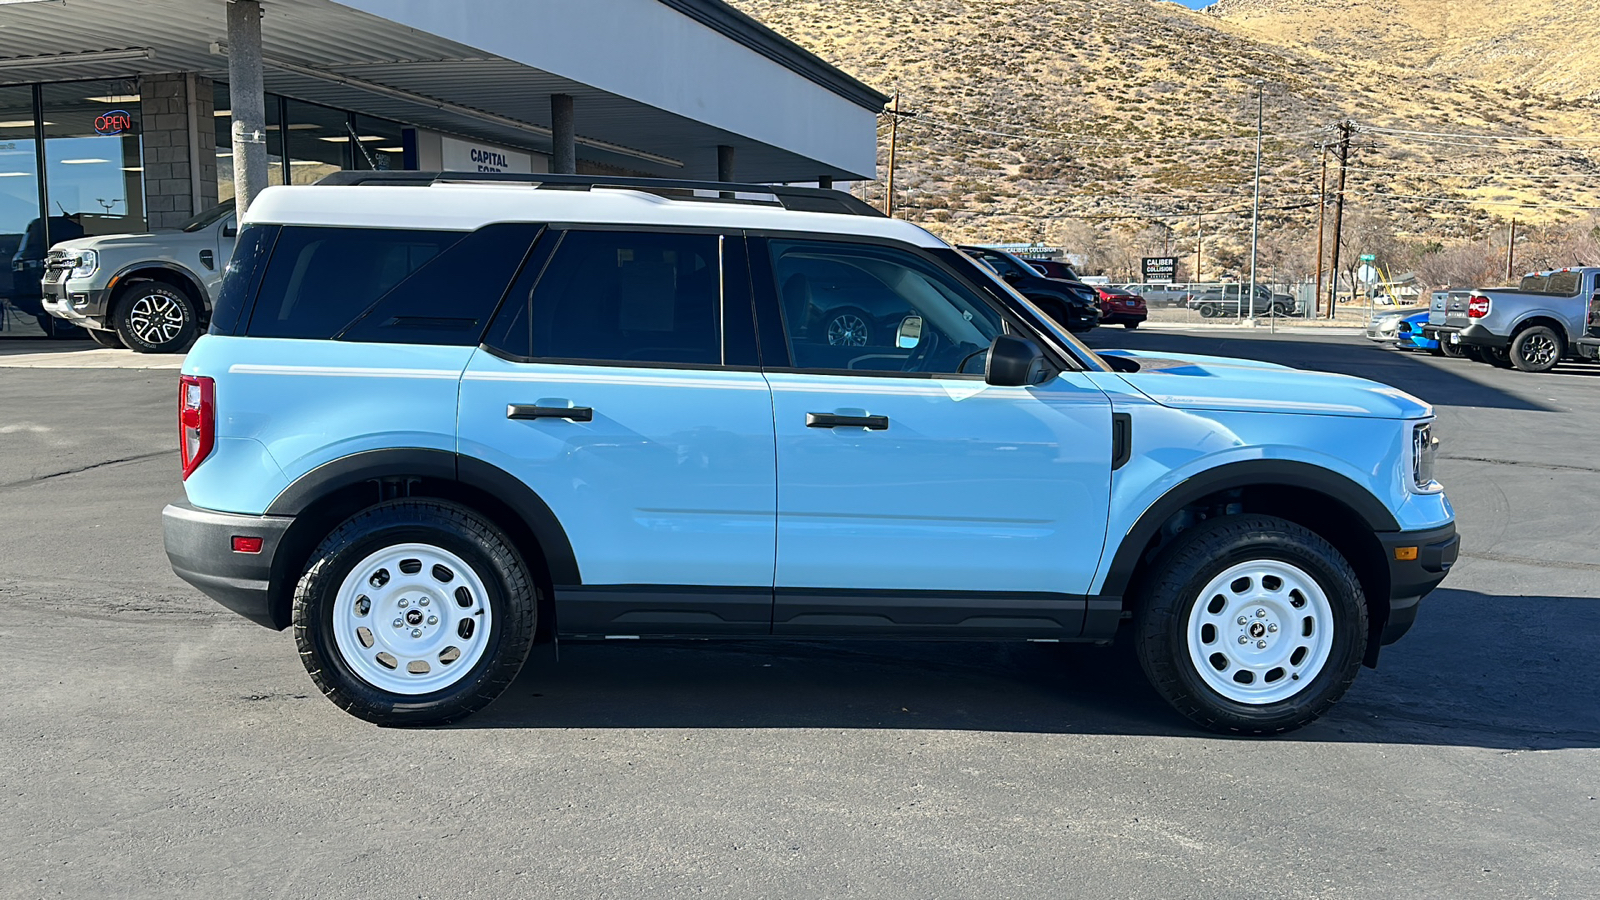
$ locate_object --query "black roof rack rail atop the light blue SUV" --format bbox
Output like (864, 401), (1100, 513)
(317, 171), (883, 218)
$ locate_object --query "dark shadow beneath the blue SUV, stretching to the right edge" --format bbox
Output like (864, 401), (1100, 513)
(454, 591), (1600, 749)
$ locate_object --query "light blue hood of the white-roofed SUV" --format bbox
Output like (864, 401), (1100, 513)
(1101, 351), (1434, 420)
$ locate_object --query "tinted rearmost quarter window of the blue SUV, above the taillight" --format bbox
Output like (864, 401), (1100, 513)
(246, 226), (466, 338)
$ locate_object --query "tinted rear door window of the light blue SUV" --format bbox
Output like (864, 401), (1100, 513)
(491, 231), (722, 365)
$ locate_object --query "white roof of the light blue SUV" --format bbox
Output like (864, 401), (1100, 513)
(243, 183), (946, 247)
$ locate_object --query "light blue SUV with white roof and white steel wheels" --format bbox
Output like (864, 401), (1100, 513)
(163, 173), (1458, 733)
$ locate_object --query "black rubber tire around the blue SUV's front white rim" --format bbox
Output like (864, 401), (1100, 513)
(1134, 516), (1366, 735)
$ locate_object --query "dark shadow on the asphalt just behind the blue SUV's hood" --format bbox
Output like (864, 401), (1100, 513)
(1085, 330), (1555, 412)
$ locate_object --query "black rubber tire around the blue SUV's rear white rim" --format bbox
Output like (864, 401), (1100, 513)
(294, 500), (539, 725)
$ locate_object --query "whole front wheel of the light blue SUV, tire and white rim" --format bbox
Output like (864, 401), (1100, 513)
(1136, 516), (1366, 735)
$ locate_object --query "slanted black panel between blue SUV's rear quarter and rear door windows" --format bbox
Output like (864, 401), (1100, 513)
(339, 223), (544, 346)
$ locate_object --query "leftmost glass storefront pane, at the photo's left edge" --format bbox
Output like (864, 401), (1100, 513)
(0, 86), (43, 333)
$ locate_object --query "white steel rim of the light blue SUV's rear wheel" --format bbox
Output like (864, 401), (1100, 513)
(333, 543), (494, 697)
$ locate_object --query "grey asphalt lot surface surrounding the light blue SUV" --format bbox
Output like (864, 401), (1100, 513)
(0, 330), (1600, 900)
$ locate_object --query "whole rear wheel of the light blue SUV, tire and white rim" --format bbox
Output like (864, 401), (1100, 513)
(294, 500), (539, 725)
